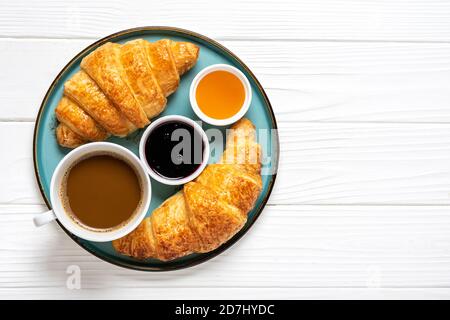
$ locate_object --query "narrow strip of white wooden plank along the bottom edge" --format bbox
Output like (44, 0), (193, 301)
(0, 287), (450, 303)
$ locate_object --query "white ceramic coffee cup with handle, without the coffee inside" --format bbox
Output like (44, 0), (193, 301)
(33, 142), (151, 242)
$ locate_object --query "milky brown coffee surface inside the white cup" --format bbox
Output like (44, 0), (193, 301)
(65, 155), (142, 229)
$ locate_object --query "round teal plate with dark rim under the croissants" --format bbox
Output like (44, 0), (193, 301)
(33, 27), (278, 271)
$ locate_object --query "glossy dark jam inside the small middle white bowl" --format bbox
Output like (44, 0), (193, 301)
(145, 121), (204, 180)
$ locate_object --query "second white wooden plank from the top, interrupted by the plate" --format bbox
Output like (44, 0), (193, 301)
(0, 39), (450, 123)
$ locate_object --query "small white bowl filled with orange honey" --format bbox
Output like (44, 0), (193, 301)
(189, 64), (252, 126)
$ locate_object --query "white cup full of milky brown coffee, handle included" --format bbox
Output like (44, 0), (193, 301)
(33, 142), (151, 242)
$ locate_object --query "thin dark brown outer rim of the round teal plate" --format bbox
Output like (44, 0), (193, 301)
(33, 26), (280, 272)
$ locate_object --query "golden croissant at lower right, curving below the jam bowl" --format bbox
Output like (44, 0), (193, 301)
(113, 119), (262, 261)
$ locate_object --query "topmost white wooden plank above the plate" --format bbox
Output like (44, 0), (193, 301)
(0, 0), (450, 41)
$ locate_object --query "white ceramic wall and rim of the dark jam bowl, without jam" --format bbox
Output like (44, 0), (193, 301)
(139, 115), (210, 186)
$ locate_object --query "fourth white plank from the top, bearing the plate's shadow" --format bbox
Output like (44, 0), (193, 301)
(0, 205), (450, 298)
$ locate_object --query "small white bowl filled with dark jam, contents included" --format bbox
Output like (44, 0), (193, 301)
(139, 115), (209, 185)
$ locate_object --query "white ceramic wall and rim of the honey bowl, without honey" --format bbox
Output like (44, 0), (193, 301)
(189, 64), (252, 126)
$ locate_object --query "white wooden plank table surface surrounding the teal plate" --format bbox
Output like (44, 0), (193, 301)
(0, 0), (450, 299)
